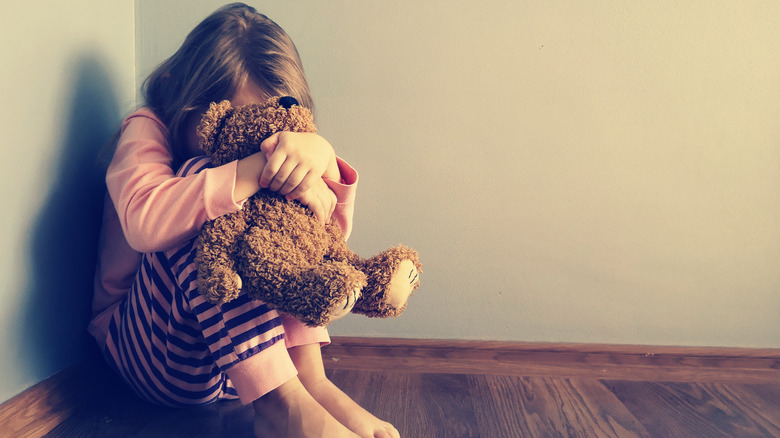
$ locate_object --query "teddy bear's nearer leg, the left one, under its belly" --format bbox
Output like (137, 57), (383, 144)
(238, 227), (366, 326)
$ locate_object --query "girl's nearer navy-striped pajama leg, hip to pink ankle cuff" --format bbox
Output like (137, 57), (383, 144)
(100, 242), (290, 406)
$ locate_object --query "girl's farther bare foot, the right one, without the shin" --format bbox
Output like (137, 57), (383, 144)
(307, 379), (400, 438)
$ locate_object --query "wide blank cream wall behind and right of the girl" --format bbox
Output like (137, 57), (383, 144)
(137, 0), (780, 347)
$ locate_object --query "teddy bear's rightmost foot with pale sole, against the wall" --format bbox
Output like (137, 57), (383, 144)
(352, 245), (422, 318)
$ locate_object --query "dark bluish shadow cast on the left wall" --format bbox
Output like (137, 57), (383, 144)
(20, 53), (120, 378)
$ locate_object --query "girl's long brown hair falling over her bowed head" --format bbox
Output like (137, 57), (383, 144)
(143, 3), (314, 162)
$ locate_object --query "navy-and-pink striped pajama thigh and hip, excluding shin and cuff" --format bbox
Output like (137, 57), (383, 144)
(105, 245), (244, 407)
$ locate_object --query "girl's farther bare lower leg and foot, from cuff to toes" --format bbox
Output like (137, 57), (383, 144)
(288, 344), (400, 438)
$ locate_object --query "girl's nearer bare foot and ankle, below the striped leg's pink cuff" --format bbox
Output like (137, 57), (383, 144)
(252, 378), (360, 438)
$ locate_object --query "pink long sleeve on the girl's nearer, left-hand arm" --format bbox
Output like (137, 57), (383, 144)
(106, 109), (241, 252)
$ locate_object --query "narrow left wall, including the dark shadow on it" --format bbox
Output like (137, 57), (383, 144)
(0, 0), (135, 402)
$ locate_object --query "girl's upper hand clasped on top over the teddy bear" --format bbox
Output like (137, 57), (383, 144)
(260, 131), (336, 198)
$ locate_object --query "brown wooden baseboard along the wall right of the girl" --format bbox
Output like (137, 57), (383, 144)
(323, 336), (780, 383)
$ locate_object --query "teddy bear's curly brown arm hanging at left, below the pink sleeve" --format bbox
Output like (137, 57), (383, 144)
(196, 211), (246, 304)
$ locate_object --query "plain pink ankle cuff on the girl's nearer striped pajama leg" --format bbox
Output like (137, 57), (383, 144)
(227, 342), (298, 404)
